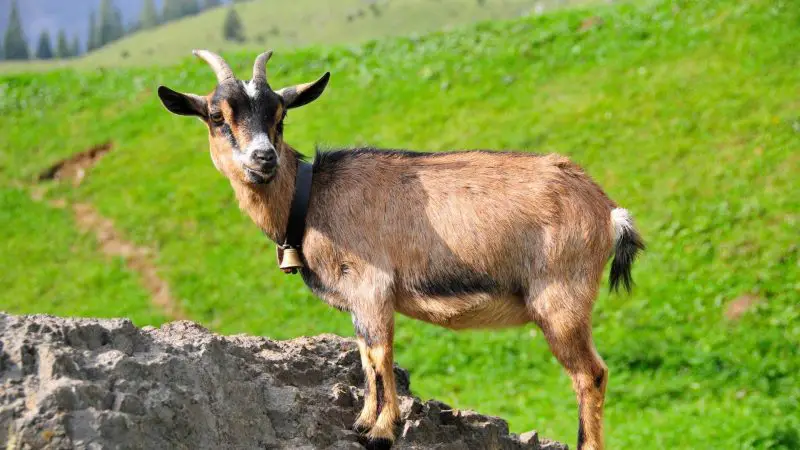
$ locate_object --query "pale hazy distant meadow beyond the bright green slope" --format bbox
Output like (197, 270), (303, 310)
(0, 0), (596, 72)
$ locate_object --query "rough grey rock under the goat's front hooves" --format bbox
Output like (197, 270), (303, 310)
(0, 313), (566, 450)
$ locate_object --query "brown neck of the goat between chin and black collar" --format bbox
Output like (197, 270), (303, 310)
(231, 143), (297, 243)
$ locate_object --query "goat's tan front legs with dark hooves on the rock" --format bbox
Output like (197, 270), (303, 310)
(353, 305), (400, 449)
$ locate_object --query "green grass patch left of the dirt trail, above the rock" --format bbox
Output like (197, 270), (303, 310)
(0, 188), (165, 326)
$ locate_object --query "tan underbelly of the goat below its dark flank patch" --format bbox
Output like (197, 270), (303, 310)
(397, 294), (531, 330)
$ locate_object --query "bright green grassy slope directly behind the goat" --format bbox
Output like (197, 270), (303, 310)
(0, 0), (800, 449)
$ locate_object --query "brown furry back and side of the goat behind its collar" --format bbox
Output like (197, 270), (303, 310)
(309, 149), (615, 300)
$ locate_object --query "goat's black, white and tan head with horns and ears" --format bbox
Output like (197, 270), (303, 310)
(158, 50), (330, 184)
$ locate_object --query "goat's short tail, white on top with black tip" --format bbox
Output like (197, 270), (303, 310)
(609, 208), (645, 292)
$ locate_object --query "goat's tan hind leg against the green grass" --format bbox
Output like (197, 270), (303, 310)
(529, 285), (608, 450)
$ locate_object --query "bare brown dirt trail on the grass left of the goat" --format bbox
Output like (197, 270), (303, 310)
(31, 142), (188, 320)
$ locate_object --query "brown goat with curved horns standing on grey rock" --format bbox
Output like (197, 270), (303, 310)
(158, 50), (644, 450)
